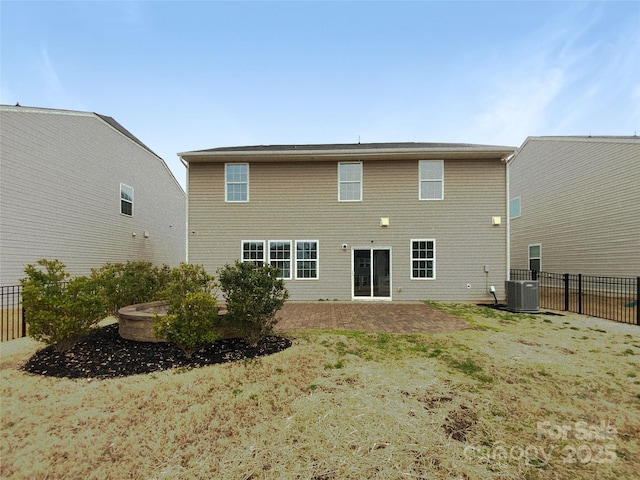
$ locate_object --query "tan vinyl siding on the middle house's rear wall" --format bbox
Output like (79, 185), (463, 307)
(189, 160), (506, 300)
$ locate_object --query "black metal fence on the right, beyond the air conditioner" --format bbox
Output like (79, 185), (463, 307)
(511, 269), (640, 325)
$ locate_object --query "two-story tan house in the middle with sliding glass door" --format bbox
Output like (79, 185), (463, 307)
(179, 143), (515, 301)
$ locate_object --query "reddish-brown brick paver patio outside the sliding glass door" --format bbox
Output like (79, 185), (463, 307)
(276, 301), (471, 334)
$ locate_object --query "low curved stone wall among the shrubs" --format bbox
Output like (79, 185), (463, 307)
(118, 300), (228, 342)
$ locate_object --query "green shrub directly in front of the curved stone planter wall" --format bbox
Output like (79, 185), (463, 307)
(153, 291), (220, 358)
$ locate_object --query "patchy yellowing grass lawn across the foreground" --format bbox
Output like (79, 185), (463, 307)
(0, 304), (640, 480)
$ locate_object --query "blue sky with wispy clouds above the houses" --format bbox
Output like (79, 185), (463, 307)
(0, 0), (640, 185)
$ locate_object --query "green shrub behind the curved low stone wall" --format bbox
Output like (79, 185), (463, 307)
(91, 261), (169, 316)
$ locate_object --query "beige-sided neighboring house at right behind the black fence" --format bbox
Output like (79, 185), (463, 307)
(509, 136), (640, 277)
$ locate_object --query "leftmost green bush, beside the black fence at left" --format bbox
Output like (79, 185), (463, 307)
(20, 259), (106, 352)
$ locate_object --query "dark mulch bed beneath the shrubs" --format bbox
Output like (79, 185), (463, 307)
(22, 324), (291, 378)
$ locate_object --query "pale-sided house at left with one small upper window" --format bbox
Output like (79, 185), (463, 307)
(0, 105), (186, 285)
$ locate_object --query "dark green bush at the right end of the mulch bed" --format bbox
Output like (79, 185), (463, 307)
(218, 261), (289, 345)
